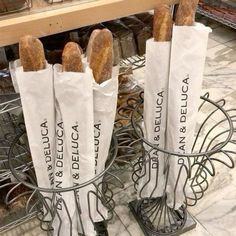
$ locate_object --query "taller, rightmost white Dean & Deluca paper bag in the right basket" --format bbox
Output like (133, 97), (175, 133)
(166, 24), (211, 209)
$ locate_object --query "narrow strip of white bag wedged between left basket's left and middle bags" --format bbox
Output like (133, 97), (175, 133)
(52, 103), (78, 236)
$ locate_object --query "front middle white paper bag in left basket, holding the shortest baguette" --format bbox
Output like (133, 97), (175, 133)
(54, 65), (96, 236)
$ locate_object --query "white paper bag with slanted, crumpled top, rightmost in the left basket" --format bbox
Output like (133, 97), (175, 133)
(93, 67), (118, 222)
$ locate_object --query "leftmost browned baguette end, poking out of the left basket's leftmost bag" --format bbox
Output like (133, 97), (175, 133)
(19, 35), (46, 71)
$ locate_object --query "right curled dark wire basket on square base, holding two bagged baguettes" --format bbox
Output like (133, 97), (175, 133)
(129, 94), (236, 236)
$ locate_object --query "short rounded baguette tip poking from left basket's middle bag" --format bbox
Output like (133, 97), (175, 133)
(62, 42), (84, 72)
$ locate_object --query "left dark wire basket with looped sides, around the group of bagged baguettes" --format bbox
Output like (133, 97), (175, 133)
(8, 125), (122, 236)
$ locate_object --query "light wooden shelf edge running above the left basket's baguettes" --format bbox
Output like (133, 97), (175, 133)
(0, 0), (178, 46)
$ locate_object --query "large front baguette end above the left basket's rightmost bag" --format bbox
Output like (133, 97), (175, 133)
(90, 29), (113, 84)
